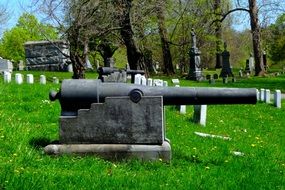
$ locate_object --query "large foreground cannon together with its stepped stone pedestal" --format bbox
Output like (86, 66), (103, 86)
(45, 79), (256, 162)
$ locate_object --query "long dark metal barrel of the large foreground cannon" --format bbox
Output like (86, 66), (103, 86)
(50, 79), (257, 115)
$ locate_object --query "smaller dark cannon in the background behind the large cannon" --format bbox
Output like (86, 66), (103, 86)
(97, 67), (145, 83)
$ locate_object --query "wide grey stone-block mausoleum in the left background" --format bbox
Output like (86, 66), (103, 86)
(24, 40), (70, 71)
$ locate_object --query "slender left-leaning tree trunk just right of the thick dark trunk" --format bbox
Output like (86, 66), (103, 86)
(157, 0), (175, 75)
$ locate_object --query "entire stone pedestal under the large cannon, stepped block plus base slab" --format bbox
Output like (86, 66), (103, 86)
(45, 96), (171, 162)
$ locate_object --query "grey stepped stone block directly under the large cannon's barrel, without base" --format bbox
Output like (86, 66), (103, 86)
(60, 96), (165, 145)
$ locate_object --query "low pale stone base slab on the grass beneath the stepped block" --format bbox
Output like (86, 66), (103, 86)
(44, 141), (171, 162)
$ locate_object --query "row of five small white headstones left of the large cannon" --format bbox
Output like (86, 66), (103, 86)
(4, 72), (59, 84)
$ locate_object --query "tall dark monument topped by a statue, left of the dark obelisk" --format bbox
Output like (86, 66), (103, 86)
(187, 28), (203, 81)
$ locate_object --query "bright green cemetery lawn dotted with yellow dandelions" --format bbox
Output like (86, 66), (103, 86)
(0, 72), (285, 189)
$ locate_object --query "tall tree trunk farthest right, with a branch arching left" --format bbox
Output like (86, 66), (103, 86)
(248, 0), (264, 76)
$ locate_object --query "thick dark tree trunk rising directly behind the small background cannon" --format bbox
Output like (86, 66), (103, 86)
(116, 0), (144, 69)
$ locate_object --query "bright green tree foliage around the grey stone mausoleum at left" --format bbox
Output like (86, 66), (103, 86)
(0, 13), (58, 61)
